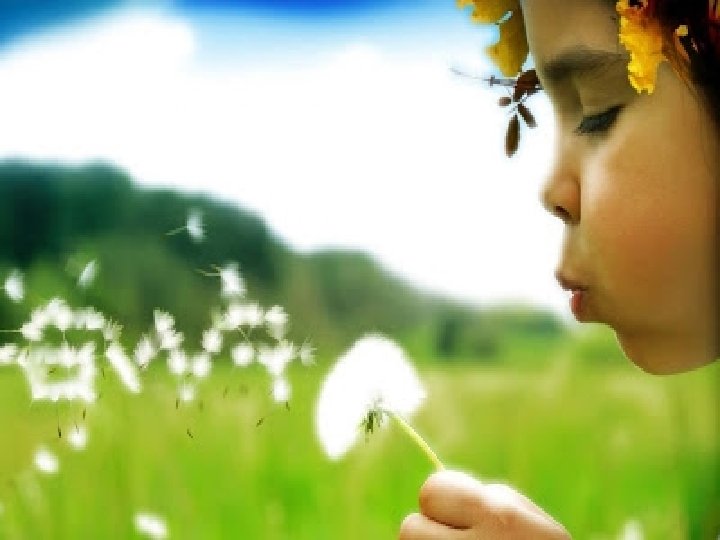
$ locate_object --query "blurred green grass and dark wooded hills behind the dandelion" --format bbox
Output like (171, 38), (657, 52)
(0, 161), (720, 540)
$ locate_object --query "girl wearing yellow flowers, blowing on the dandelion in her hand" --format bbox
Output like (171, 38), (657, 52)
(400, 0), (720, 540)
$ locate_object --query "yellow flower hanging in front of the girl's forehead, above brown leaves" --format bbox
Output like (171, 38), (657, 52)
(457, 0), (528, 77)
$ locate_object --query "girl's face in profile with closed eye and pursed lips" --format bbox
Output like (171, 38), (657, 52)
(523, 0), (720, 373)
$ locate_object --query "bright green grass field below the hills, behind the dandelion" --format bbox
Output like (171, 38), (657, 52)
(0, 359), (720, 540)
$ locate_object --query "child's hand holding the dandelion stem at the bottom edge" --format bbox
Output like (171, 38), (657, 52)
(400, 471), (570, 540)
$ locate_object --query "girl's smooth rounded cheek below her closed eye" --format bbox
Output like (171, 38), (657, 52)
(582, 155), (714, 318)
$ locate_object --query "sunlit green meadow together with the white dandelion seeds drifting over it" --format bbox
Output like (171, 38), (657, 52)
(0, 214), (720, 540)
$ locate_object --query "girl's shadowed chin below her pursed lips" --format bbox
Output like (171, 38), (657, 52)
(615, 330), (718, 375)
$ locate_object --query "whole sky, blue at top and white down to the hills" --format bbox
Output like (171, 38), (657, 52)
(0, 0), (569, 317)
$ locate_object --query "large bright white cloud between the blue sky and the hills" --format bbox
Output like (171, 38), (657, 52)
(0, 9), (565, 316)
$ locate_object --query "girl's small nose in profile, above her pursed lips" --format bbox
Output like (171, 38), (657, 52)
(540, 140), (580, 225)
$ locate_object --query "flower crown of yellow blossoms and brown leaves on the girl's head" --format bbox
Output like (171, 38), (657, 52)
(457, 0), (720, 156)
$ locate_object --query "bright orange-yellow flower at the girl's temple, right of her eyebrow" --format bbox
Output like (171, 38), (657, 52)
(616, 0), (665, 94)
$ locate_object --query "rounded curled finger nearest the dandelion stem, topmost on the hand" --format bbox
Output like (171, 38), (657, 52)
(420, 471), (482, 529)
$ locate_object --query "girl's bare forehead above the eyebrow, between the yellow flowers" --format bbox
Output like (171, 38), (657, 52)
(522, 0), (624, 70)
